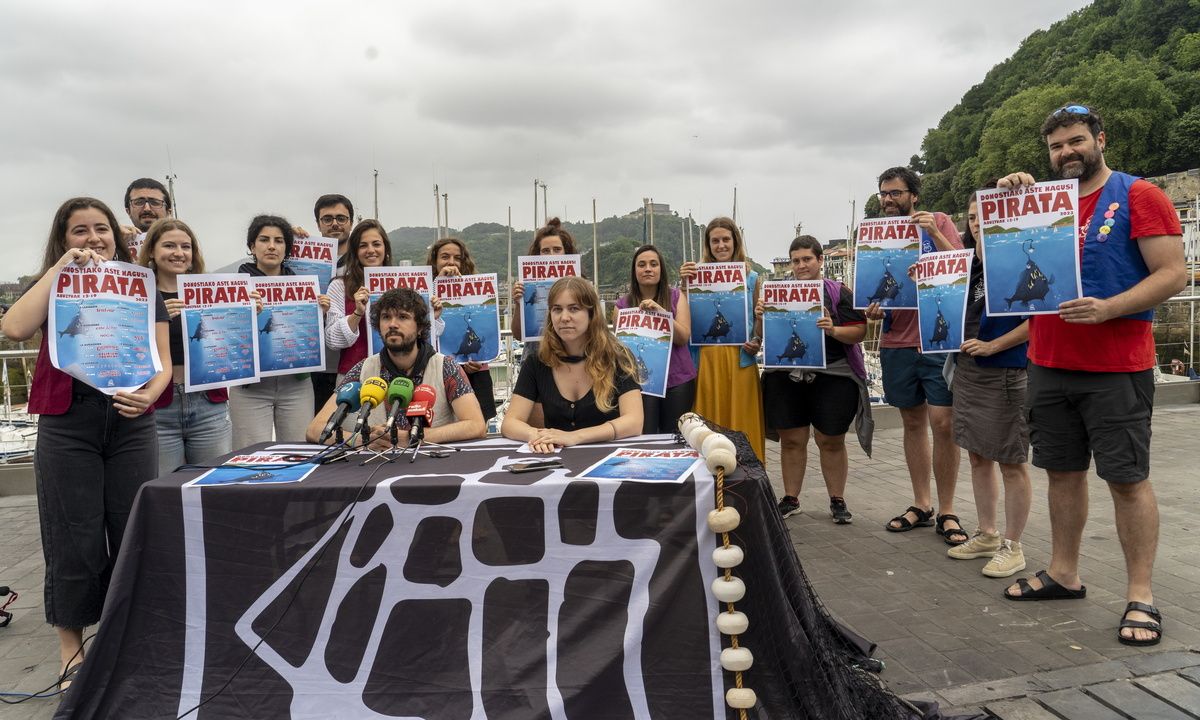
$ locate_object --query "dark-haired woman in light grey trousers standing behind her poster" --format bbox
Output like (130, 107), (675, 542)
(229, 215), (329, 446)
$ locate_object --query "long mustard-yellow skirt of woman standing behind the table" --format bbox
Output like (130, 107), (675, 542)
(695, 346), (767, 463)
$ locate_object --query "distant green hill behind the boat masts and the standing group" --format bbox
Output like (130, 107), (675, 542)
(388, 212), (763, 289)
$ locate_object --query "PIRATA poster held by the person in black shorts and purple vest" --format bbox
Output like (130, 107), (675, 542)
(762, 280), (826, 370)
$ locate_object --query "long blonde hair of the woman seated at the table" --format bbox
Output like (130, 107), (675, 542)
(538, 276), (637, 413)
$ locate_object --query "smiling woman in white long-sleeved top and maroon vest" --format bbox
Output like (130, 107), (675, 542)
(325, 220), (391, 377)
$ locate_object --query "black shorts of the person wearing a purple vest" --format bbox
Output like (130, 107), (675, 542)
(762, 370), (858, 436)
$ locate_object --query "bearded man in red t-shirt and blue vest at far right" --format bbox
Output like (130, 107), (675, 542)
(998, 104), (1187, 646)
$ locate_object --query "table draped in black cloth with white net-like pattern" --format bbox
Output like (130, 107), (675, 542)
(56, 433), (936, 720)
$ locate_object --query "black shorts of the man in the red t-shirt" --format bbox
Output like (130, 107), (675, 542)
(1025, 364), (1154, 482)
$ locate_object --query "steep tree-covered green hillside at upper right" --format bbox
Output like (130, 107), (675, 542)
(883, 0), (1200, 216)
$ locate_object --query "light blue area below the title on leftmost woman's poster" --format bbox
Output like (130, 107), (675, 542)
(54, 298), (155, 392)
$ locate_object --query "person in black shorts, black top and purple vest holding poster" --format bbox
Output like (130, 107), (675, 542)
(755, 235), (871, 524)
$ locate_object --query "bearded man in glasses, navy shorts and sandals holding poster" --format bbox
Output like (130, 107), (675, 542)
(866, 168), (967, 545)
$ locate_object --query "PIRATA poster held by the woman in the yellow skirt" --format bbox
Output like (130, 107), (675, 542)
(688, 263), (750, 346)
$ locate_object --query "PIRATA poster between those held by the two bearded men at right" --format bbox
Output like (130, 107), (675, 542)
(913, 250), (974, 355)
